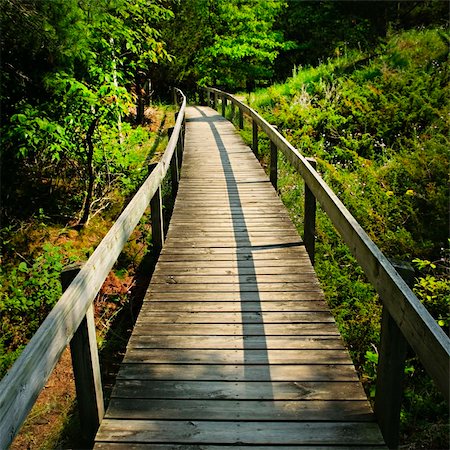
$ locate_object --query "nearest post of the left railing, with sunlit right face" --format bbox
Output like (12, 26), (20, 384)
(61, 267), (105, 443)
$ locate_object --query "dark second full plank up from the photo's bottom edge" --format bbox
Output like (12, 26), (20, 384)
(105, 398), (374, 422)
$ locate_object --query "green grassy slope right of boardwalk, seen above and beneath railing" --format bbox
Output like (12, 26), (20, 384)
(241, 30), (450, 448)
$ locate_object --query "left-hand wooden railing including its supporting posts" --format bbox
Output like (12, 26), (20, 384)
(0, 89), (186, 449)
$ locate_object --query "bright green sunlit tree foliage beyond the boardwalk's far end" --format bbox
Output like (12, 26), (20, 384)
(160, 0), (292, 89)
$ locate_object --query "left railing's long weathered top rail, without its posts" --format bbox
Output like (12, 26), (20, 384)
(0, 89), (186, 449)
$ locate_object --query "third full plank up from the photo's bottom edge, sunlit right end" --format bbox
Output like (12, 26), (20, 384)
(112, 379), (367, 401)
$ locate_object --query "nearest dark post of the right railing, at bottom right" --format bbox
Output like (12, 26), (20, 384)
(374, 261), (414, 449)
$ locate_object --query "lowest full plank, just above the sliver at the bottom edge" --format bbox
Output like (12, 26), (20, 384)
(97, 419), (383, 445)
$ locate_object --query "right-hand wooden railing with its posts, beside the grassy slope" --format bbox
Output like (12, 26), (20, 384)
(203, 88), (450, 448)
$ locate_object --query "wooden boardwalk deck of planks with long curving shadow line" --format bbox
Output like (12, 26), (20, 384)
(95, 107), (384, 450)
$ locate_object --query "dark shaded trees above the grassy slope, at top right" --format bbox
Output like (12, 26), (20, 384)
(276, 0), (448, 79)
